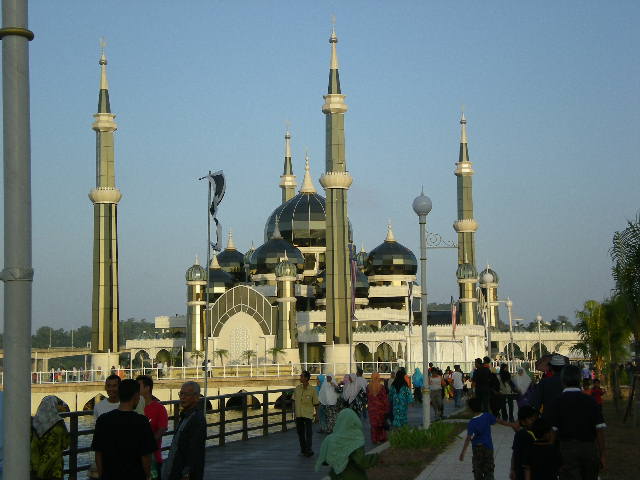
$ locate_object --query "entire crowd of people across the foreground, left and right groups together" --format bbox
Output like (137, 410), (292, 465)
(31, 355), (606, 480)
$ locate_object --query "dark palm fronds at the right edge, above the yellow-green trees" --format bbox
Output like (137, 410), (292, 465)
(609, 215), (640, 365)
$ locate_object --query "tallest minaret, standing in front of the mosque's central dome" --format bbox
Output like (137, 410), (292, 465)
(320, 22), (352, 354)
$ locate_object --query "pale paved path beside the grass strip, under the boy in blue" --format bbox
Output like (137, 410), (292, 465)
(416, 425), (513, 480)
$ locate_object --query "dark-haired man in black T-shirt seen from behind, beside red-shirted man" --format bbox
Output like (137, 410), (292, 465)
(91, 379), (156, 480)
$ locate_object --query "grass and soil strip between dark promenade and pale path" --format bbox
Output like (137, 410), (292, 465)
(367, 422), (467, 480)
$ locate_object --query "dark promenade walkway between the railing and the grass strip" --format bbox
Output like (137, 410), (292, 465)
(205, 401), (460, 480)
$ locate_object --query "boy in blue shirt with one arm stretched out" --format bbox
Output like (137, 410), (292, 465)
(460, 397), (513, 480)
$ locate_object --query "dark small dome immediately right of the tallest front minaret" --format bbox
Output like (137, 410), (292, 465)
(365, 225), (418, 276)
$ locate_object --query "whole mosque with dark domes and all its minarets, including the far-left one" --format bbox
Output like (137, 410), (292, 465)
(90, 25), (568, 372)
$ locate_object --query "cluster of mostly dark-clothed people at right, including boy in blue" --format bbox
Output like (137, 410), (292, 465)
(460, 354), (606, 480)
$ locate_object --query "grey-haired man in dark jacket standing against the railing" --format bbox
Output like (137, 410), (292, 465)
(162, 382), (207, 480)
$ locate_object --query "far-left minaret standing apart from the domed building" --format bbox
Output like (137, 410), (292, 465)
(89, 43), (122, 353)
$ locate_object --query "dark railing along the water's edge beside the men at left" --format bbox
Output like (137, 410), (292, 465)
(60, 388), (294, 480)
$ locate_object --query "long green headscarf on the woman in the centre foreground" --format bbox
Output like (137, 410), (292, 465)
(316, 408), (364, 474)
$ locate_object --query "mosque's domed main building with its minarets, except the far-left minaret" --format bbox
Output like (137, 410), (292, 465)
(176, 26), (498, 370)
